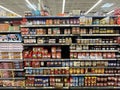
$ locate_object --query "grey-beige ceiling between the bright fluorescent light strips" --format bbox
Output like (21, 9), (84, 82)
(0, 0), (120, 16)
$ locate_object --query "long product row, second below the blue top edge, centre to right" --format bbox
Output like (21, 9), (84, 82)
(21, 27), (119, 35)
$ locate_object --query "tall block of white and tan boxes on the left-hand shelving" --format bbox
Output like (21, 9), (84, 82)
(0, 43), (23, 60)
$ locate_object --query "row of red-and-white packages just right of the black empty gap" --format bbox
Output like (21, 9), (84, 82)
(70, 51), (116, 60)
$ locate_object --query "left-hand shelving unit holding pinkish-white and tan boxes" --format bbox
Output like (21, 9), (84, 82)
(0, 17), (25, 89)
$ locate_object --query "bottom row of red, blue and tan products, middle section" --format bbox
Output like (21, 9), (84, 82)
(26, 77), (69, 87)
